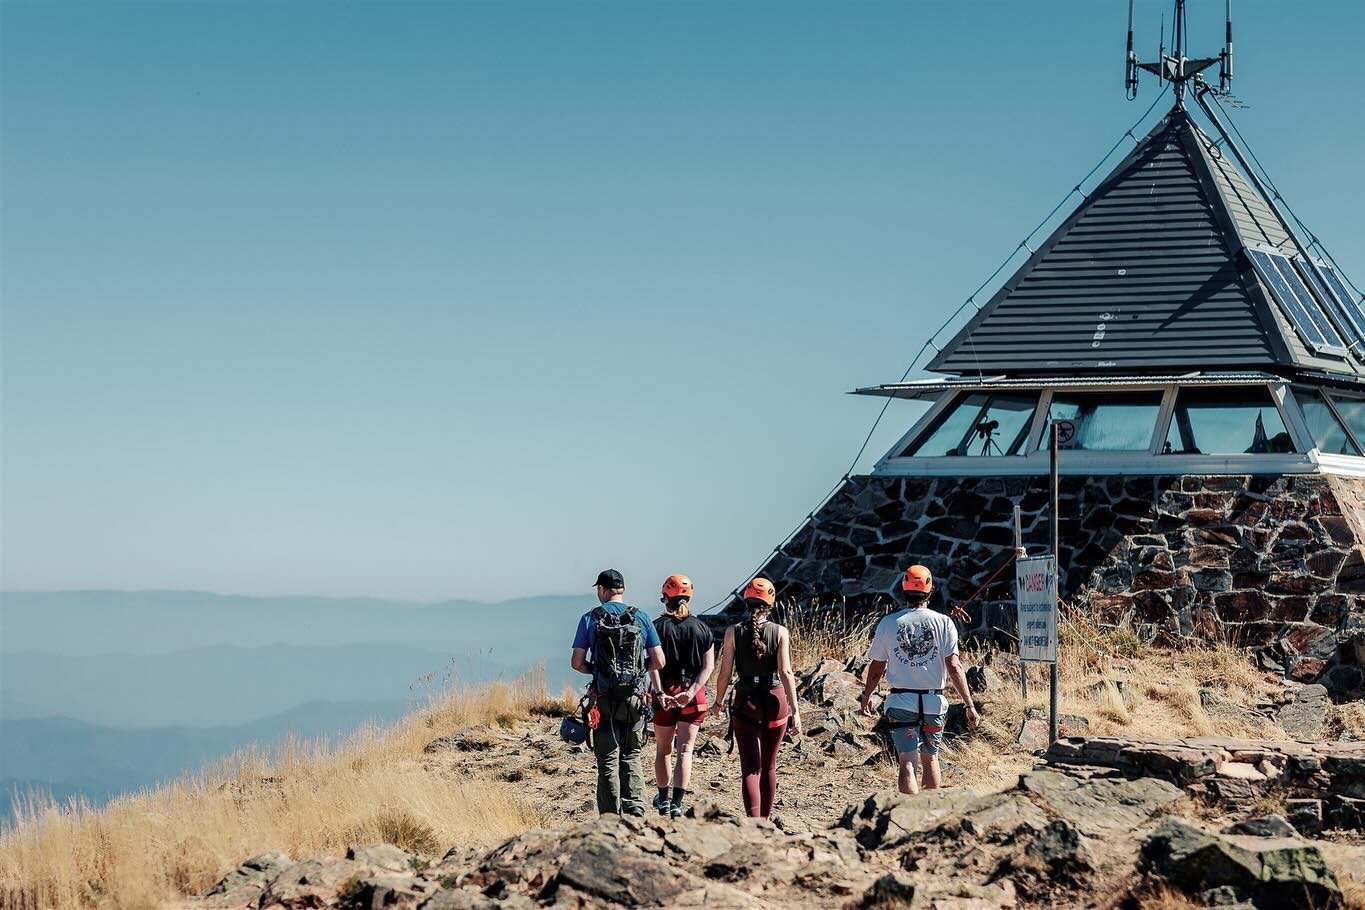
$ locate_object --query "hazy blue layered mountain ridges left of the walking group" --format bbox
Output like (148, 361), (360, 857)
(0, 591), (595, 817)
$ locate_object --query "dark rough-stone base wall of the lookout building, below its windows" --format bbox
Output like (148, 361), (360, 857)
(763, 475), (1365, 689)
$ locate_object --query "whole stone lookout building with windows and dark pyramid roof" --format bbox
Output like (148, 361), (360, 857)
(742, 40), (1365, 689)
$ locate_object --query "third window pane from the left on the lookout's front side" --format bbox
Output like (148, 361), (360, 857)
(1162, 387), (1294, 454)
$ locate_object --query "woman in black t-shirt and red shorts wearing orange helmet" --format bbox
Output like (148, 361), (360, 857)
(654, 576), (715, 819)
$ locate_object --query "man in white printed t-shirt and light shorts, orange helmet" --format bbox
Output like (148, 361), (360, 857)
(863, 566), (980, 793)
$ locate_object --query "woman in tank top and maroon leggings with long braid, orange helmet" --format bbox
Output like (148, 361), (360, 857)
(715, 578), (801, 819)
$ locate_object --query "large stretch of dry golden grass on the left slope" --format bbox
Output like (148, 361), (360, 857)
(0, 671), (560, 909)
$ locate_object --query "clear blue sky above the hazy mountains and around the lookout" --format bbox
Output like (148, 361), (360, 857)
(0, 0), (1365, 602)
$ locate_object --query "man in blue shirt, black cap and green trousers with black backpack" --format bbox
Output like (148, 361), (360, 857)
(569, 569), (663, 816)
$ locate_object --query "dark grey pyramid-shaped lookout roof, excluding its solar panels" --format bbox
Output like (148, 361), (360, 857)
(928, 108), (1362, 375)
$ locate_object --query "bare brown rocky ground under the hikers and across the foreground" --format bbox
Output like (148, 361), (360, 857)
(194, 662), (1365, 910)
